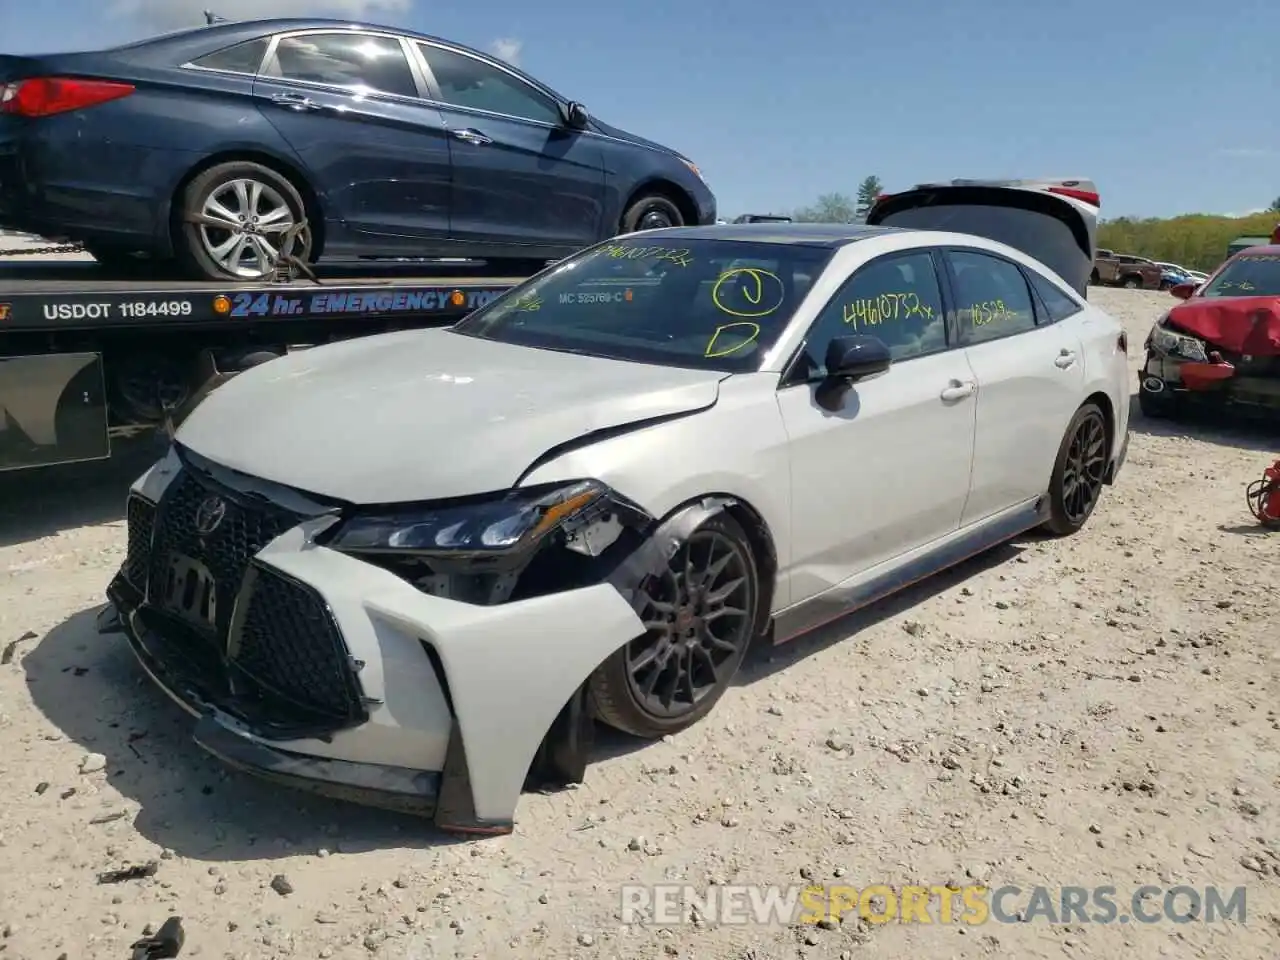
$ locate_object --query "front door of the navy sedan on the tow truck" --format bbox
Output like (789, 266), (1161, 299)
(419, 44), (604, 250)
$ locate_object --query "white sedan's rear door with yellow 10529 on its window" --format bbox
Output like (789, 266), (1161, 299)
(947, 248), (1084, 525)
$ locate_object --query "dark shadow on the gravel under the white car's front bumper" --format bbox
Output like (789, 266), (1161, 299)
(19, 607), (460, 863)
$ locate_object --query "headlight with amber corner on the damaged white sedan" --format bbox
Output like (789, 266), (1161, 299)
(326, 480), (608, 556)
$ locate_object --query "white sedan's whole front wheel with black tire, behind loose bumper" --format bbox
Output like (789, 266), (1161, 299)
(588, 513), (760, 740)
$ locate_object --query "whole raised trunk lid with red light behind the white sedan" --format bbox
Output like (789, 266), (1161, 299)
(867, 178), (1098, 297)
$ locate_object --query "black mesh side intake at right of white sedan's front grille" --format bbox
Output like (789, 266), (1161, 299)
(228, 564), (364, 721)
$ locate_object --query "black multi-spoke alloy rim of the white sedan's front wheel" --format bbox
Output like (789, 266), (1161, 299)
(626, 530), (755, 718)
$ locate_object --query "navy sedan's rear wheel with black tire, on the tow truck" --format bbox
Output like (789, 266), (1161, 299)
(174, 160), (312, 282)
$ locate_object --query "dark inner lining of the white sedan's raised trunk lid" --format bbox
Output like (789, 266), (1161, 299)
(874, 191), (1093, 297)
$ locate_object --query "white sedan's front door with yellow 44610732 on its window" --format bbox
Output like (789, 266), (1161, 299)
(778, 251), (975, 602)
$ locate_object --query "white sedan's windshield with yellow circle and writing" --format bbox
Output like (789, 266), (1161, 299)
(453, 236), (832, 372)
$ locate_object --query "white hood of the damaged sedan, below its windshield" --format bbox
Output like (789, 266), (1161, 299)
(177, 329), (724, 504)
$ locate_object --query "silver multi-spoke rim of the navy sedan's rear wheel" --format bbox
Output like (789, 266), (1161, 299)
(200, 179), (297, 280)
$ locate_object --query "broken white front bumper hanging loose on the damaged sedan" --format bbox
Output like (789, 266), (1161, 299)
(110, 454), (644, 833)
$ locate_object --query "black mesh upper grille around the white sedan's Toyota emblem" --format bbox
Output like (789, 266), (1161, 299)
(151, 467), (303, 637)
